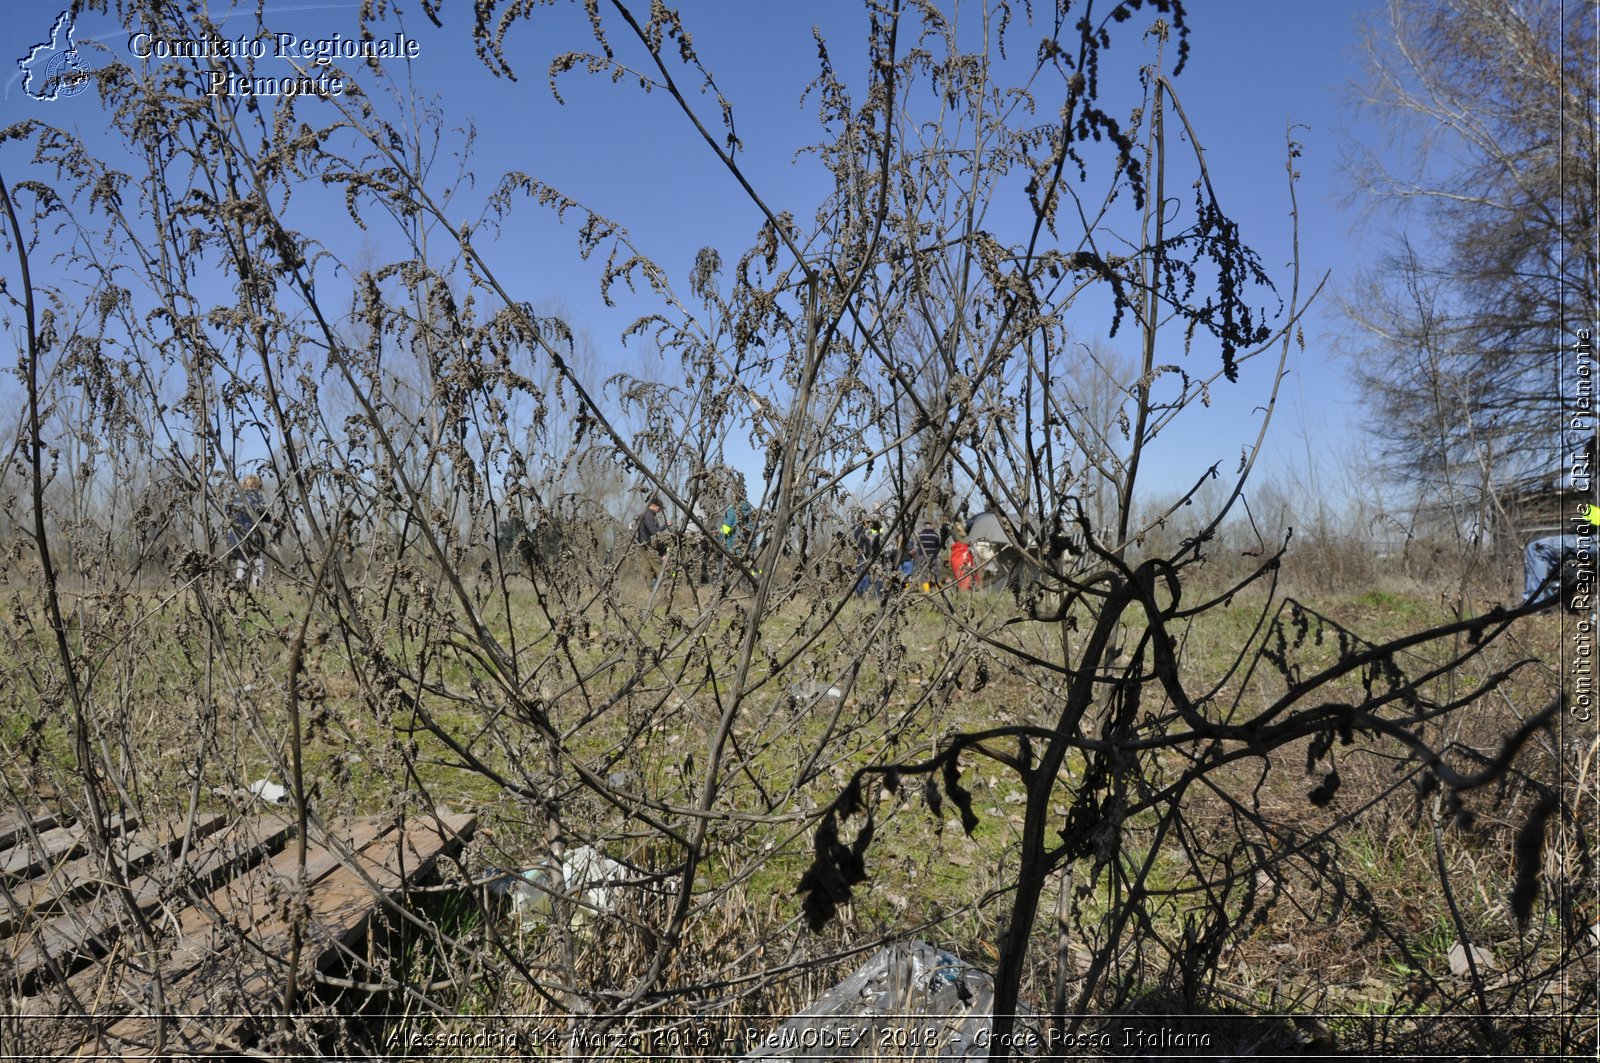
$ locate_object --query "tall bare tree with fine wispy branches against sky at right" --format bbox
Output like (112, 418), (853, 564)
(1350, 0), (1600, 489)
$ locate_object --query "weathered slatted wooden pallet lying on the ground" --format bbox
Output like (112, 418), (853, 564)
(0, 810), (475, 1058)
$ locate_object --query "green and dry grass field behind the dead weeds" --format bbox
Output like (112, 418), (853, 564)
(0, 560), (1600, 1053)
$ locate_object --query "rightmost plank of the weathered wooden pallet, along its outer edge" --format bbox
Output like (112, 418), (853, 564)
(94, 815), (475, 1058)
